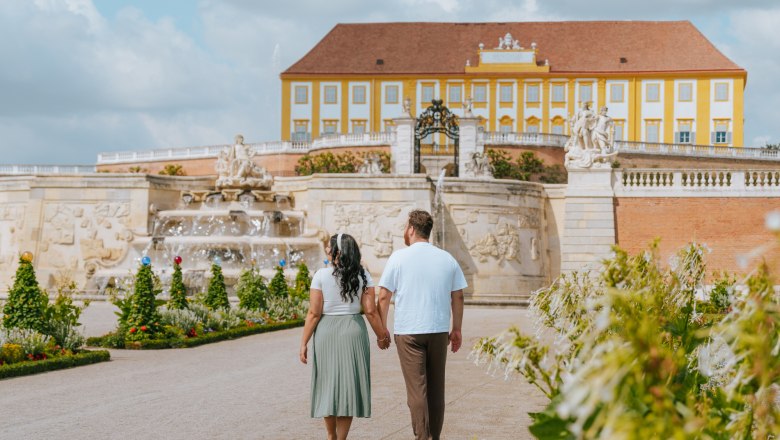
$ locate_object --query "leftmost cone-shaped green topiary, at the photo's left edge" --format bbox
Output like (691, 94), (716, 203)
(3, 258), (49, 331)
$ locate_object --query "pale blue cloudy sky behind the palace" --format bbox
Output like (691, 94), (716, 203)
(0, 0), (780, 164)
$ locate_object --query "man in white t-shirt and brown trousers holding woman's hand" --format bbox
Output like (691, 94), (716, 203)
(378, 210), (467, 440)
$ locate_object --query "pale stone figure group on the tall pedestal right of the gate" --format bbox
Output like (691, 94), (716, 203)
(564, 102), (617, 168)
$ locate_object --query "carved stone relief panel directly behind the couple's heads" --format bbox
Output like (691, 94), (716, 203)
(322, 202), (414, 258)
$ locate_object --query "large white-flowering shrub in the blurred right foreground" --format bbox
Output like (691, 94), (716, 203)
(472, 245), (780, 439)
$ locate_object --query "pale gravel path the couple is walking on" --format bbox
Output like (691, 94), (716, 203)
(0, 302), (546, 439)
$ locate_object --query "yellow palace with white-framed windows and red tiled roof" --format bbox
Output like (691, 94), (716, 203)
(281, 21), (747, 147)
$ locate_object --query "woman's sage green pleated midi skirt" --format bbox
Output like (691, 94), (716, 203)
(311, 315), (371, 417)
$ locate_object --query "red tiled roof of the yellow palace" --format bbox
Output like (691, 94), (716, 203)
(282, 21), (745, 76)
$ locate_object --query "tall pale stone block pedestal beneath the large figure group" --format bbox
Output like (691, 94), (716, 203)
(561, 168), (615, 273)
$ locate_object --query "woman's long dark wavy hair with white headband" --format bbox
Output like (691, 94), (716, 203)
(329, 234), (368, 302)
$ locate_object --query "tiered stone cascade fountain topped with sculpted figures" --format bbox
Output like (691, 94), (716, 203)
(93, 135), (324, 291)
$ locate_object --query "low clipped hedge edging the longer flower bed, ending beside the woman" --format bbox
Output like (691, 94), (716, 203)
(87, 319), (304, 350)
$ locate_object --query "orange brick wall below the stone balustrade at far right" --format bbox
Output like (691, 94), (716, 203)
(615, 197), (780, 273)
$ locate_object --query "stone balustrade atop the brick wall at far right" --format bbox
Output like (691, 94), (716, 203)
(613, 169), (780, 197)
